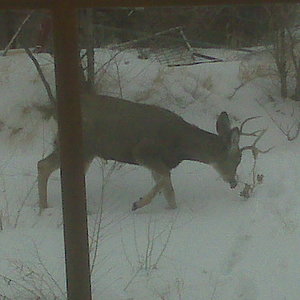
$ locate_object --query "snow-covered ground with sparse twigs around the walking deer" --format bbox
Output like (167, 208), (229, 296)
(0, 49), (300, 300)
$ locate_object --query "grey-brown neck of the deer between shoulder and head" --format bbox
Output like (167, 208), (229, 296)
(183, 125), (226, 164)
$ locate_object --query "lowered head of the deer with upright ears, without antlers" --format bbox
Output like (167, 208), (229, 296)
(213, 112), (242, 188)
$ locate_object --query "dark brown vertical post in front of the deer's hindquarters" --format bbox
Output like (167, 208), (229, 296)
(52, 0), (91, 300)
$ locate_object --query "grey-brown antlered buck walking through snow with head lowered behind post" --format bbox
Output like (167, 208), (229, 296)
(38, 95), (270, 210)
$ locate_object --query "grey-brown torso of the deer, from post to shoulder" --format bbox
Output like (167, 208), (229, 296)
(82, 96), (190, 168)
